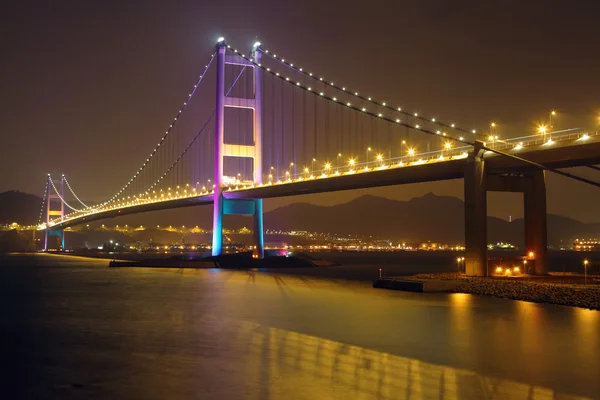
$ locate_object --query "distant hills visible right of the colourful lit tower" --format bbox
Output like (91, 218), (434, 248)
(265, 193), (600, 245)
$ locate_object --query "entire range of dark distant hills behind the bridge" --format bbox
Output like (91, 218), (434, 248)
(0, 191), (600, 246)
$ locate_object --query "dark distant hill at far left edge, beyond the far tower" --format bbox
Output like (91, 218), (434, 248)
(0, 190), (42, 225)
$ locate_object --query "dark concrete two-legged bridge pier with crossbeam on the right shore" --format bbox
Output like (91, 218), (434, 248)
(464, 141), (548, 276)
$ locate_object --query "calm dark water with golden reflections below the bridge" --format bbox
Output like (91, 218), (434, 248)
(0, 255), (600, 400)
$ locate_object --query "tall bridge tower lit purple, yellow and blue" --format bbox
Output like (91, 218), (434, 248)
(212, 40), (264, 258)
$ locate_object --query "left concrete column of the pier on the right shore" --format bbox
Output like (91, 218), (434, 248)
(464, 142), (488, 276)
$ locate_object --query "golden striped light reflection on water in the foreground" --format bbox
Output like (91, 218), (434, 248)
(226, 322), (585, 400)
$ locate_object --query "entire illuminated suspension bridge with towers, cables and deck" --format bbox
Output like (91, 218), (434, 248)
(39, 38), (600, 276)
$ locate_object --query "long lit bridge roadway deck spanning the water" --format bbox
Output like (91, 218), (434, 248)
(52, 135), (600, 229)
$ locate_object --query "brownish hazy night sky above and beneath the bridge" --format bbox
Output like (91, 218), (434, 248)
(0, 0), (600, 222)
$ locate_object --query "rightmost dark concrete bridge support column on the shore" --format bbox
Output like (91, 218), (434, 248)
(523, 170), (548, 275)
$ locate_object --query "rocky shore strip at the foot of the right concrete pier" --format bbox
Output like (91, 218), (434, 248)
(411, 274), (600, 310)
